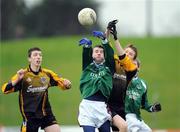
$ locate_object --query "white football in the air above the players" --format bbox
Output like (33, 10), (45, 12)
(78, 8), (96, 26)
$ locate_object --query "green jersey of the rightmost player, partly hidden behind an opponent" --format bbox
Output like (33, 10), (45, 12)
(125, 77), (151, 120)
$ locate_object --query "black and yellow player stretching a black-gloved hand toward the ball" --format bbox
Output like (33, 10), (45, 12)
(107, 20), (137, 132)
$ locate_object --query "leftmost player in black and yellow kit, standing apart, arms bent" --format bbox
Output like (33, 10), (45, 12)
(2, 47), (71, 132)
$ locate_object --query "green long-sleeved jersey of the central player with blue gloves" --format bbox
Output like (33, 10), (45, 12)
(80, 43), (114, 99)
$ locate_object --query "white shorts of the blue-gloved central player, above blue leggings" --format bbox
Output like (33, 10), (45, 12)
(78, 99), (111, 128)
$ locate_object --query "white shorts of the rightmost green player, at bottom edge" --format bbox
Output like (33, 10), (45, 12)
(126, 113), (152, 132)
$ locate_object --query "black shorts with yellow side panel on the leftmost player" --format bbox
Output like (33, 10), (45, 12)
(21, 115), (57, 132)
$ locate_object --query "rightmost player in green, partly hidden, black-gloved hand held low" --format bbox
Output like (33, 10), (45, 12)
(125, 60), (161, 132)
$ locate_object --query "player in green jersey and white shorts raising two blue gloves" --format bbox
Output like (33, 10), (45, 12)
(78, 28), (114, 132)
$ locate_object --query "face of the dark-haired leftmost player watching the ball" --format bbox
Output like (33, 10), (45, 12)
(29, 50), (42, 67)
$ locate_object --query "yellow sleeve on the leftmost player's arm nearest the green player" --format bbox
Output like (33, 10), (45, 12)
(42, 69), (67, 90)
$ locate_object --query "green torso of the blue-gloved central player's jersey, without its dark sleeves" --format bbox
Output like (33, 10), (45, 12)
(80, 63), (112, 98)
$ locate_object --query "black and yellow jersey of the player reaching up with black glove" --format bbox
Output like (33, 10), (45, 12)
(108, 55), (137, 113)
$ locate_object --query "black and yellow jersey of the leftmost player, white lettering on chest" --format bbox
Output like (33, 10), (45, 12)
(2, 67), (66, 120)
